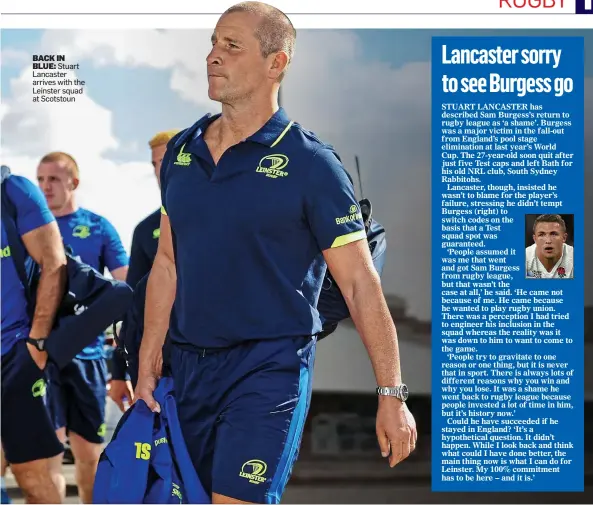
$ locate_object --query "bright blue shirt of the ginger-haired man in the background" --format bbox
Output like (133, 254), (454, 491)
(56, 208), (128, 359)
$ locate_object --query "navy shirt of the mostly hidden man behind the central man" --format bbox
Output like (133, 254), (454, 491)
(126, 209), (161, 288)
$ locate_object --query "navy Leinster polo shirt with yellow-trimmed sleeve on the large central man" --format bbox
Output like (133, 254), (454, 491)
(161, 109), (366, 348)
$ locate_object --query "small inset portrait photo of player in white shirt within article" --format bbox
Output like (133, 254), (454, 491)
(525, 214), (574, 279)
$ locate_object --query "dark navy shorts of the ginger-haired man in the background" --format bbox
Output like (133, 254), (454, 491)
(47, 358), (107, 444)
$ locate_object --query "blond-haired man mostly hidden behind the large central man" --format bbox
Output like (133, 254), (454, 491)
(109, 130), (179, 412)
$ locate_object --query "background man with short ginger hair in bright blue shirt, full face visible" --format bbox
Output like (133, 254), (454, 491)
(37, 152), (128, 503)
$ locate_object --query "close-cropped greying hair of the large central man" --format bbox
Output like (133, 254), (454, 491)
(223, 2), (296, 80)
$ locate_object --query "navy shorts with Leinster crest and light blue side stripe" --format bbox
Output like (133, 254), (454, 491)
(171, 337), (316, 503)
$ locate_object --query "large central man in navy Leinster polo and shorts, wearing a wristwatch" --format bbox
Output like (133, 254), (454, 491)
(136, 2), (416, 503)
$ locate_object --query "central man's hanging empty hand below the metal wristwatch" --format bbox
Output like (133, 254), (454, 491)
(376, 396), (418, 468)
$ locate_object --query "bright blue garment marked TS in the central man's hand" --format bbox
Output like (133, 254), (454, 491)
(93, 377), (211, 503)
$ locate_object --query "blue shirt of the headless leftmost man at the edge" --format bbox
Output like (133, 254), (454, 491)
(0, 175), (55, 356)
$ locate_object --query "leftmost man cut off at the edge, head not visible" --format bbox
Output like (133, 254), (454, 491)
(0, 168), (66, 503)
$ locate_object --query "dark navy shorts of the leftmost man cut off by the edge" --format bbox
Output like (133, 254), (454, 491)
(1, 340), (64, 464)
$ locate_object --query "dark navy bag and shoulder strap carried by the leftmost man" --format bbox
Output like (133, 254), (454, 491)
(2, 165), (133, 369)
